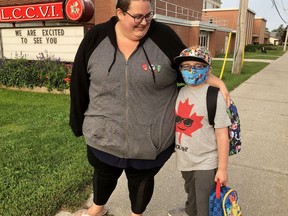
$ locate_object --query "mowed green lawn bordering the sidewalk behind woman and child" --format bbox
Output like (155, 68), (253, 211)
(0, 52), (280, 216)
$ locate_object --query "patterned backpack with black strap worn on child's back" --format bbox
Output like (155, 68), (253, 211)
(206, 86), (241, 156)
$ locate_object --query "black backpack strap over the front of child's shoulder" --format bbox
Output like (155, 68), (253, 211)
(206, 86), (219, 126)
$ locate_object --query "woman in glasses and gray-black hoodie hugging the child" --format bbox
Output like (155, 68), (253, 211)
(70, 0), (228, 216)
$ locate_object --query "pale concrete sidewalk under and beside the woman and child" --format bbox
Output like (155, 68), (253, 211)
(57, 52), (288, 216)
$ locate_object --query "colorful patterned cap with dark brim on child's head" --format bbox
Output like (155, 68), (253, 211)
(174, 46), (212, 65)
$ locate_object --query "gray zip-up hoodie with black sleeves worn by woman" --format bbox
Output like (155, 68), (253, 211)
(70, 17), (185, 160)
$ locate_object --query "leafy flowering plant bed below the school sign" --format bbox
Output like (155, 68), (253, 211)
(0, 54), (71, 91)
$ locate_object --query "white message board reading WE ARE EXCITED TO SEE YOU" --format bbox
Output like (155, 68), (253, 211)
(1, 26), (84, 62)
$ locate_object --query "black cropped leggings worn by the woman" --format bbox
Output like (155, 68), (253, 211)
(87, 148), (161, 214)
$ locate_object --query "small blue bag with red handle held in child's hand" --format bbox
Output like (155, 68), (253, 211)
(209, 181), (242, 216)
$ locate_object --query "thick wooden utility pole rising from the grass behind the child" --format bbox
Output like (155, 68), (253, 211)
(232, 0), (248, 74)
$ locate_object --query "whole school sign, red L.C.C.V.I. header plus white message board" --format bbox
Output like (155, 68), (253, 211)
(0, 0), (94, 62)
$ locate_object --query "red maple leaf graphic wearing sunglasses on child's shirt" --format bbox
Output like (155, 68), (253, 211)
(176, 99), (204, 144)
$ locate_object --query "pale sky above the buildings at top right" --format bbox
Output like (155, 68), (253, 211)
(221, 0), (288, 31)
